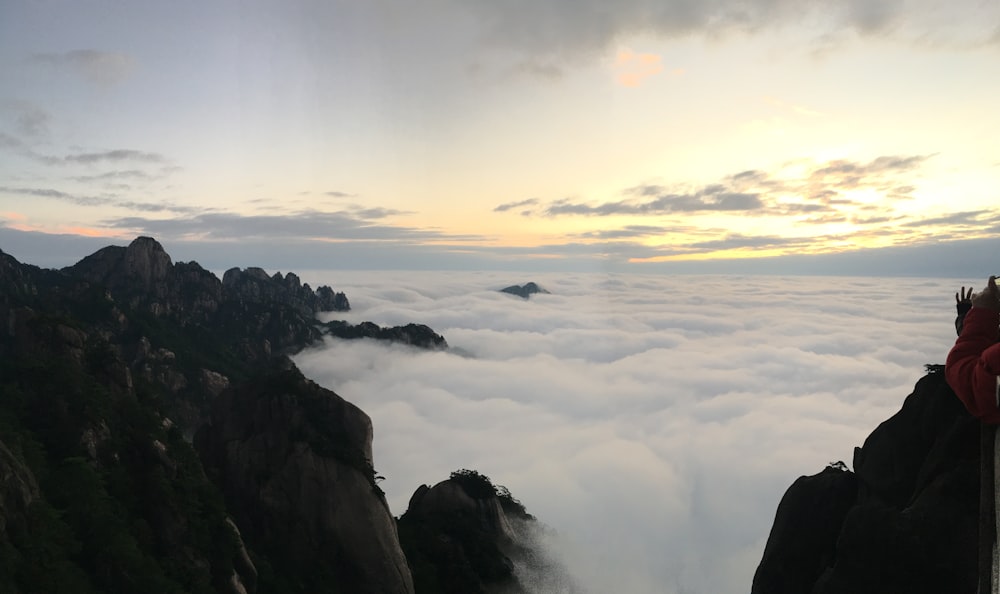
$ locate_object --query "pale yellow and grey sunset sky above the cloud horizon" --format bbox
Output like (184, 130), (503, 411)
(0, 0), (1000, 278)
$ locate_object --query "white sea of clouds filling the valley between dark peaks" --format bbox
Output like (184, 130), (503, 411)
(295, 271), (960, 594)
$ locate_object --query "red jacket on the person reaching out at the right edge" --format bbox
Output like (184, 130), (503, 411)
(945, 307), (1000, 425)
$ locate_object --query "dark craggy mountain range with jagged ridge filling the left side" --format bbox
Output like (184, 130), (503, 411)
(0, 237), (540, 594)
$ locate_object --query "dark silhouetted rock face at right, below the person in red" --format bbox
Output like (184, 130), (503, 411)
(752, 366), (979, 594)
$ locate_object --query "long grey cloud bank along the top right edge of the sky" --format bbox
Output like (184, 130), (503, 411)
(454, 0), (1000, 61)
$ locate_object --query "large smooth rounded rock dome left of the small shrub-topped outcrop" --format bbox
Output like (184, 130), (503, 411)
(196, 361), (413, 594)
